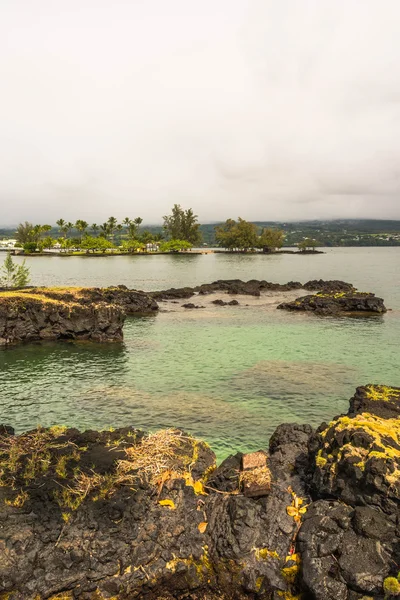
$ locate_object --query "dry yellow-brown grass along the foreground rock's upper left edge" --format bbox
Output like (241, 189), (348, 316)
(0, 427), (205, 510)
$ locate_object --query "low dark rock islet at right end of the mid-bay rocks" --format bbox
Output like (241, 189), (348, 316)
(277, 291), (386, 315)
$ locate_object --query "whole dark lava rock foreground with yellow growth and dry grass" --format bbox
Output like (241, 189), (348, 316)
(0, 385), (400, 600)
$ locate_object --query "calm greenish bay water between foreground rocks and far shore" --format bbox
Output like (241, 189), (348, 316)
(0, 248), (400, 458)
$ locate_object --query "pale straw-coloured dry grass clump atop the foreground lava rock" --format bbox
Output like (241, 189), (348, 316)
(118, 429), (199, 483)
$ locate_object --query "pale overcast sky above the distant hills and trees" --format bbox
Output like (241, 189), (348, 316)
(0, 0), (400, 225)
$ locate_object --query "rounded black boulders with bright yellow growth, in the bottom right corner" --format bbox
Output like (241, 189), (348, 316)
(298, 386), (400, 600)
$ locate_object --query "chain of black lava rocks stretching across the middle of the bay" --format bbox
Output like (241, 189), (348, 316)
(0, 279), (386, 346)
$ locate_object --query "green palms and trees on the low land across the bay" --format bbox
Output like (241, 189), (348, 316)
(15, 209), (318, 253)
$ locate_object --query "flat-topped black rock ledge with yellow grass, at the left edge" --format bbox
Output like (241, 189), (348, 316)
(0, 286), (158, 346)
